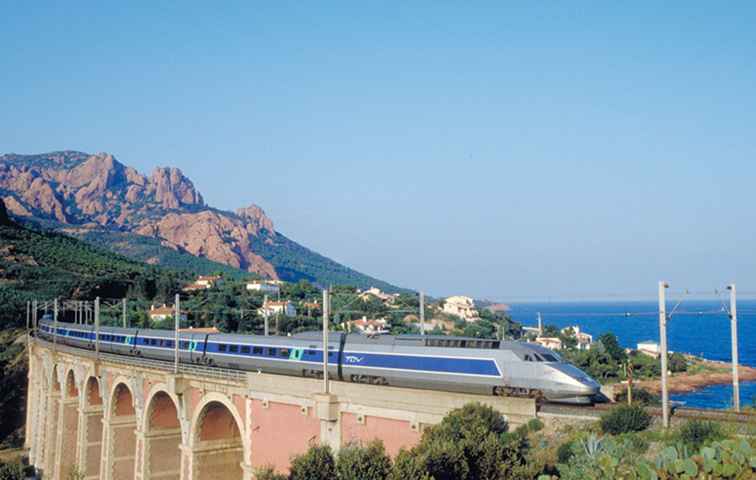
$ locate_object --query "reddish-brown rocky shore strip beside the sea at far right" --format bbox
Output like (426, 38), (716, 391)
(614, 360), (756, 395)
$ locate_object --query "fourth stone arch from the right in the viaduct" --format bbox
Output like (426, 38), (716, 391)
(79, 375), (104, 478)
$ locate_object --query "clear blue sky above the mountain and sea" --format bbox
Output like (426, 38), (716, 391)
(0, 2), (756, 300)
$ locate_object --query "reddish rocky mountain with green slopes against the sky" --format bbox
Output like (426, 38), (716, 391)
(0, 151), (404, 291)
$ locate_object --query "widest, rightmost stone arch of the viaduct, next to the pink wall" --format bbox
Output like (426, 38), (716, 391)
(190, 393), (247, 480)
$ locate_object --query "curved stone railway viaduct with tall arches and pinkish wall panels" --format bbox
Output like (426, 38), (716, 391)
(26, 338), (536, 480)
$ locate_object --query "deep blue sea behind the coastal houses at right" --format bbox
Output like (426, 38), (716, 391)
(509, 299), (756, 408)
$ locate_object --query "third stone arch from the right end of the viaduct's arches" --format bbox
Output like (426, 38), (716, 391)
(106, 379), (137, 480)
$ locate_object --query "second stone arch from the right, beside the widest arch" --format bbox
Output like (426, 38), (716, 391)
(142, 384), (183, 480)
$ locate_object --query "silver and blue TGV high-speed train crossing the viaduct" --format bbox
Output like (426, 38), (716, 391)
(39, 319), (599, 404)
